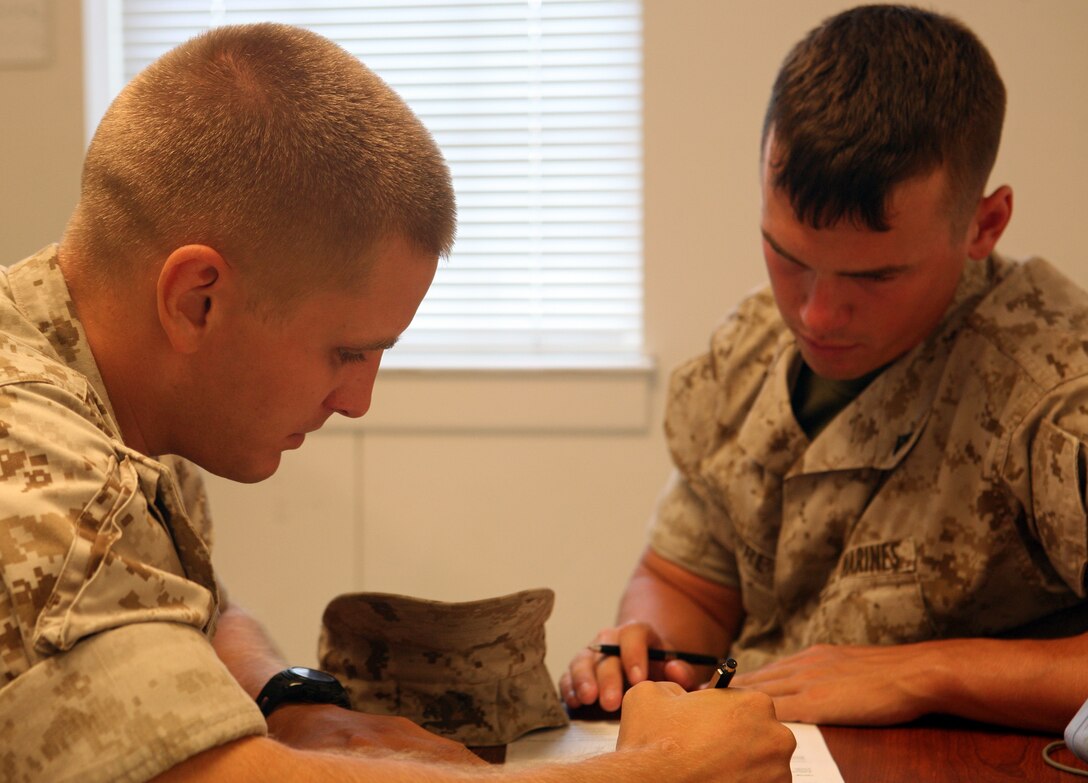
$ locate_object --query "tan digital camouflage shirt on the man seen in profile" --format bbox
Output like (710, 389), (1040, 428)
(0, 247), (265, 783)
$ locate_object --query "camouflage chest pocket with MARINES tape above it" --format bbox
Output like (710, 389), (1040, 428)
(802, 538), (937, 646)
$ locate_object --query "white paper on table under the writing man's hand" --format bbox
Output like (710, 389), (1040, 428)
(506, 720), (843, 783)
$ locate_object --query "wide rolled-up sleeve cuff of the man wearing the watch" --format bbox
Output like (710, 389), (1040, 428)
(0, 623), (267, 783)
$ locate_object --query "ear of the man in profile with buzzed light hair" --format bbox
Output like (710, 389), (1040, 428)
(156, 245), (231, 353)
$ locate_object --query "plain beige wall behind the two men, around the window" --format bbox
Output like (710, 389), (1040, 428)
(0, 0), (1088, 674)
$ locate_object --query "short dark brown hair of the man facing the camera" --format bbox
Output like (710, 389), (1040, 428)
(763, 5), (1005, 232)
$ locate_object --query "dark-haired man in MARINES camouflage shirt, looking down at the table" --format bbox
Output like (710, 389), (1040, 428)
(560, 5), (1088, 731)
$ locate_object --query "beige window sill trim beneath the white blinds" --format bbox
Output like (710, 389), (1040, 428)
(325, 359), (656, 434)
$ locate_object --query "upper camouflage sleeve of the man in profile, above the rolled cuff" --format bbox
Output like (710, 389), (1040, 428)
(0, 384), (215, 665)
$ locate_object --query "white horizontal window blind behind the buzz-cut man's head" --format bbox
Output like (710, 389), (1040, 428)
(111, 0), (643, 368)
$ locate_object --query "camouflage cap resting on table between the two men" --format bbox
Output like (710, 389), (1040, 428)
(318, 589), (568, 745)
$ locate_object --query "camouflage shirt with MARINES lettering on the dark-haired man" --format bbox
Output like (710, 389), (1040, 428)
(651, 257), (1088, 671)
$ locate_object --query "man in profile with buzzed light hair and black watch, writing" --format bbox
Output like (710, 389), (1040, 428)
(0, 25), (793, 781)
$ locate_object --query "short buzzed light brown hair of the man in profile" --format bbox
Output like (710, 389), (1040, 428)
(65, 24), (456, 301)
